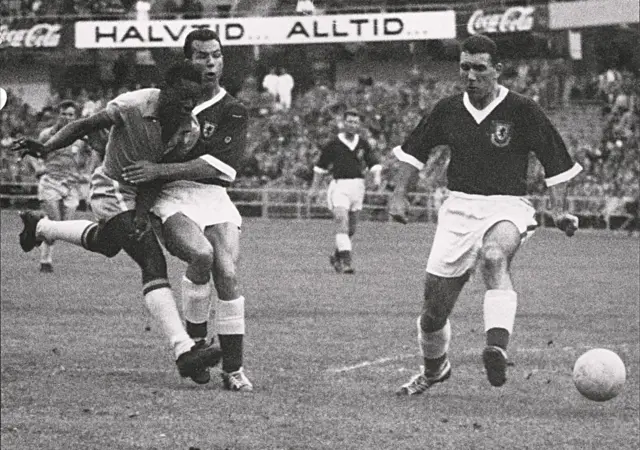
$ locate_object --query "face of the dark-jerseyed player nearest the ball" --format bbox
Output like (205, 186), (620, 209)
(460, 52), (502, 99)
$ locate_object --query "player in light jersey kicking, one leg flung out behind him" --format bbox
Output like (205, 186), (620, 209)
(17, 62), (221, 382)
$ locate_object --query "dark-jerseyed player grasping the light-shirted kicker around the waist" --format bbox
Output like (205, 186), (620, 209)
(125, 29), (253, 392)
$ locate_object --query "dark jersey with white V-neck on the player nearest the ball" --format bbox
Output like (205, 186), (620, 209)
(394, 87), (582, 196)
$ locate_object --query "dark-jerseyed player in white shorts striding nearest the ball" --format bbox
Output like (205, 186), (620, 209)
(389, 35), (582, 395)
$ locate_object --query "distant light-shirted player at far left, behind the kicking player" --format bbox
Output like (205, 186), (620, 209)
(25, 100), (99, 273)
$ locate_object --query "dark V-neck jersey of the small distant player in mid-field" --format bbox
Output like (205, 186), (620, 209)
(316, 133), (379, 179)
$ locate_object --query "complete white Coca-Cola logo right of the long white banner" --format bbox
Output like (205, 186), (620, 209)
(467, 6), (536, 34)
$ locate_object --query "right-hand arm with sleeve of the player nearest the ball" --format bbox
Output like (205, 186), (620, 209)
(530, 104), (582, 236)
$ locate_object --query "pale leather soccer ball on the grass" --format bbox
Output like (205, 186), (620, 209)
(573, 348), (627, 402)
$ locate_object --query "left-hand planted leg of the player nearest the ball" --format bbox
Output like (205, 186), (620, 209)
(397, 272), (469, 395)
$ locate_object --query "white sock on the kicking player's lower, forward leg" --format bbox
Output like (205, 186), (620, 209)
(144, 287), (194, 359)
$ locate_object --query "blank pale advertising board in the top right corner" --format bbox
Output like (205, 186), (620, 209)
(549, 0), (640, 30)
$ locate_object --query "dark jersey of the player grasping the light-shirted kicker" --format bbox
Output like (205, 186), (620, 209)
(165, 89), (249, 186)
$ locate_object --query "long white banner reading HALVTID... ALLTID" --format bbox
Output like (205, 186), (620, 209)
(75, 11), (456, 48)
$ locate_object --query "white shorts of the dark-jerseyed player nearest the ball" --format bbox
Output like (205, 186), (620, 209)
(427, 192), (538, 278)
